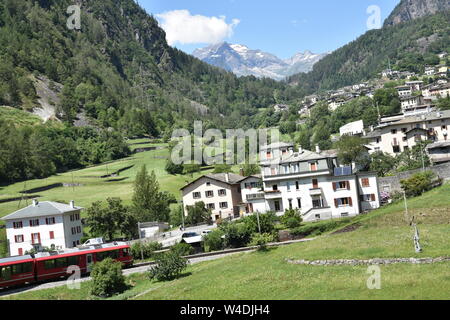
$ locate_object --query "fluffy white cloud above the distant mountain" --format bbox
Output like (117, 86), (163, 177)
(156, 10), (240, 45)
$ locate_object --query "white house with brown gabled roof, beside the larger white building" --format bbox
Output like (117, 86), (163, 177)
(181, 173), (245, 221)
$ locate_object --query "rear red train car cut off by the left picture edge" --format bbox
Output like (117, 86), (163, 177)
(0, 255), (36, 288)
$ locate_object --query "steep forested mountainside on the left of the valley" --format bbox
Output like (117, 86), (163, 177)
(0, 0), (302, 136)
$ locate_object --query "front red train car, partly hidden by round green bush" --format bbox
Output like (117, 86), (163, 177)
(35, 242), (133, 281)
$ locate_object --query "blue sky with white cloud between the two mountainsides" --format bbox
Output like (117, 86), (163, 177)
(139, 0), (400, 58)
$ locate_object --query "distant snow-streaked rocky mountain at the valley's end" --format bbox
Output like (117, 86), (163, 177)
(193, 42), (326, 80)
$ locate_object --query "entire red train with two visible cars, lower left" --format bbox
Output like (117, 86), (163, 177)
(0, 242), (133, 288)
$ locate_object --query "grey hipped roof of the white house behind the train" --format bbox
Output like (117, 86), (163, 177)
(2, 201), (83, 220)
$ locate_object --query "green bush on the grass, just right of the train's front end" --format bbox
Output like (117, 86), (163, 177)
(149, 251), (188, 281)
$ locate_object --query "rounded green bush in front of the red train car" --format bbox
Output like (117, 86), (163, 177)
(91, 258), (126, 297)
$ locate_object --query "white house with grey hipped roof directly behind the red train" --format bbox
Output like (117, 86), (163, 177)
(3, 200), (83, 256)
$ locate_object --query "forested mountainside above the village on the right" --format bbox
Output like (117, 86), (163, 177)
(288, 11), (450, 93)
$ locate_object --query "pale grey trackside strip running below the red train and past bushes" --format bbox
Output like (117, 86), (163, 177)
(0, 251), (251, 297)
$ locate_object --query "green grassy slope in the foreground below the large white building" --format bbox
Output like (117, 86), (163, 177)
(3, 184), (450, 300)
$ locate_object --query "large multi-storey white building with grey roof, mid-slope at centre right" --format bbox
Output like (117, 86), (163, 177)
(260, 150), (379, 221)
